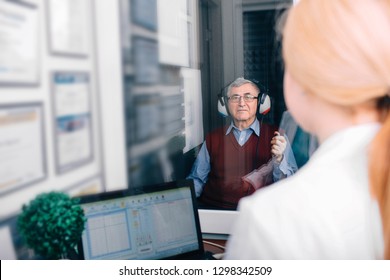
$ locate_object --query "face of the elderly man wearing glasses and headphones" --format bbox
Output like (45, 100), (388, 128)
(228, 84), (259, 126)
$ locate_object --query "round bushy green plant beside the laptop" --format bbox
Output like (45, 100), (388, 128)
(17, 192), (85, 259)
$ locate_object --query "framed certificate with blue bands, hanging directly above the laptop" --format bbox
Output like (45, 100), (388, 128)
(51, 72), (93, 174)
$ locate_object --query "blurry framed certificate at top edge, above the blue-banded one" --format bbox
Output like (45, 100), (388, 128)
(48, 0), (90, 57)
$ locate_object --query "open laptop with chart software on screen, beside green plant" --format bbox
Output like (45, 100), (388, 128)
(74, 180), (212, 260)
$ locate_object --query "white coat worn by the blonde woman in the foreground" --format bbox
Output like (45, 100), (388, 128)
(225, 124), (384, 260)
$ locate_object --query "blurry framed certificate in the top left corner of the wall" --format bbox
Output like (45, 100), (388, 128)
(0, 0), (39, 86)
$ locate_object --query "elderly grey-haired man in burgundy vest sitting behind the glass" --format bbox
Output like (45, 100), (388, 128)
(187, 78), (297, 209)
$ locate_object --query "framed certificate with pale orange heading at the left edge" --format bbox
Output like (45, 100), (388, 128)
(0, 103), (46, 196)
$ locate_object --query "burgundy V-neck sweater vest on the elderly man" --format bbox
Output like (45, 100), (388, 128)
(200, 124), (276, 209)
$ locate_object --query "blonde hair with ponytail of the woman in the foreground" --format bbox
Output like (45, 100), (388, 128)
(283, 0), (390, 259)
